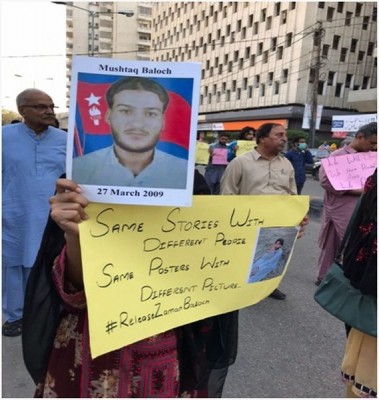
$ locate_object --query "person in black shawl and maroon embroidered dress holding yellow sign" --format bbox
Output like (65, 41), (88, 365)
(22, 174), (236, 398)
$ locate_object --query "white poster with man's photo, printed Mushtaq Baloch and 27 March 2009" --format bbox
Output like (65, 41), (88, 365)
(67, 56), (201, 206)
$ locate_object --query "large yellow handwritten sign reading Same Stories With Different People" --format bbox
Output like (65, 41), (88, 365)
(80, 196), (309, 357)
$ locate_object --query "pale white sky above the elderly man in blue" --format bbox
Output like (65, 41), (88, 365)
(0, 0), (67, 113)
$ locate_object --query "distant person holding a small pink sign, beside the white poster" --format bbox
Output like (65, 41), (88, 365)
(204, 132), (229, 194)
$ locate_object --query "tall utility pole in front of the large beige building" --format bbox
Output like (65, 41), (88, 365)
(309, 21), (323, 148)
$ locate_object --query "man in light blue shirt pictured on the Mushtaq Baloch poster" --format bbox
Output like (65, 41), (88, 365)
(72, 77), (188, 189)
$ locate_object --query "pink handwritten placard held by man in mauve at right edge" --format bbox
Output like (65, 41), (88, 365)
(321, 151), (377, 190)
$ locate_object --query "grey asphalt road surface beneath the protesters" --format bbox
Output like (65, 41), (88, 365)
(2, 177), (345, 398)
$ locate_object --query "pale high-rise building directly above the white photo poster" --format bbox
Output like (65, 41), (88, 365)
(58, 2), (152, 109)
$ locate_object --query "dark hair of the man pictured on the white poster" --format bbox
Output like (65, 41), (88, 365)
(105, 76), (169, 112)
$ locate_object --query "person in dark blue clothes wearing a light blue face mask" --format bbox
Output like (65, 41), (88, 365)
(285, 136), (313, 194)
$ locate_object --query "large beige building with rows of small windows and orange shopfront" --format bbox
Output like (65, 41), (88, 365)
(151, 1), (377, 141)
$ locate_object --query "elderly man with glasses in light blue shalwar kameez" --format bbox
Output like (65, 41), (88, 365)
(2, 89), (67, 336)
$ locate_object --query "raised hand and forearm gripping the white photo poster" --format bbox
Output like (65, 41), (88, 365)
(50, 179), (88, 289)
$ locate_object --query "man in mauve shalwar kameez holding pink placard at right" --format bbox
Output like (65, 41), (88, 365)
(315, 122), (377, 286)
